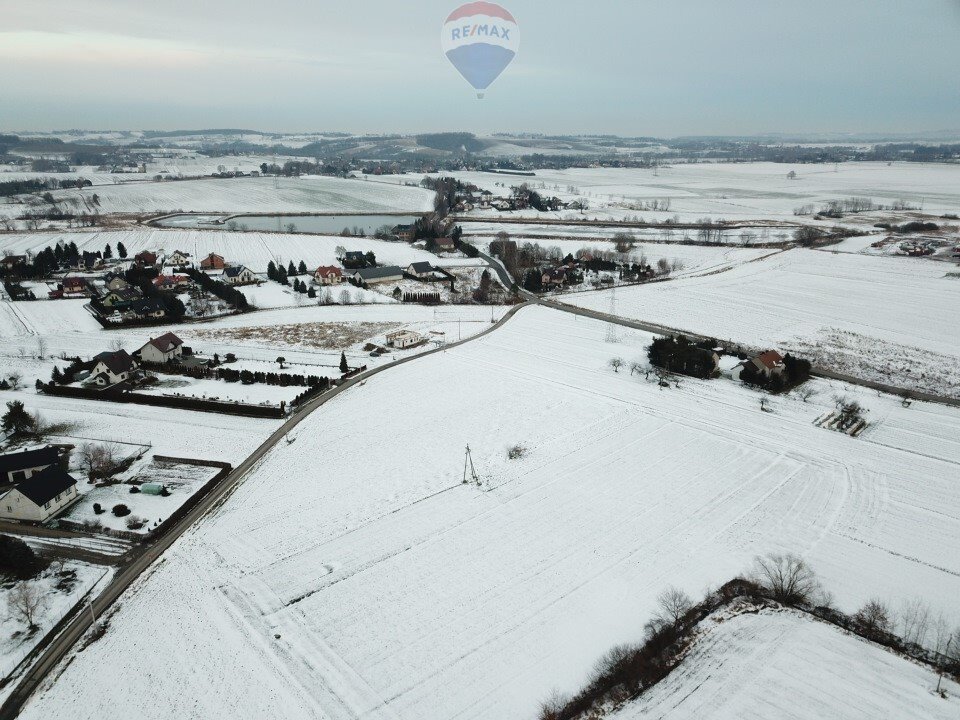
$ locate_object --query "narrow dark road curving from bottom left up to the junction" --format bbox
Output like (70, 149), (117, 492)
(0, 303), (527, 720)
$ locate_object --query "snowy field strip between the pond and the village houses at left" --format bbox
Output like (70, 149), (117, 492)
(0, 229), (482, 279)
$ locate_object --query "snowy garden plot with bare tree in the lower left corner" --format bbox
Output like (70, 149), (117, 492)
(0, 560), (113, 702)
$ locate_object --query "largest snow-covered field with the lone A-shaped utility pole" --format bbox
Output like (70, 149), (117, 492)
(23, 308), (960, 720)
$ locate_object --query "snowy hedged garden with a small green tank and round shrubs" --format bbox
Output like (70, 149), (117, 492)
(63, 462), (220, 536)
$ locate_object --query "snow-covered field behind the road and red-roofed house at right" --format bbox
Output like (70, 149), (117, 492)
(563, 250), (960, 397)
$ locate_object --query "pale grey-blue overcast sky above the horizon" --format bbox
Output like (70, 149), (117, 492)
(0, 0), (960, 136)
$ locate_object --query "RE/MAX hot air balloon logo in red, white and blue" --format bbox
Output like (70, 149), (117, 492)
(441, 2), (520, 98)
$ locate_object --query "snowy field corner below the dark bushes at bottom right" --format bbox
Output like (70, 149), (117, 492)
(608, 611), (960, 720)
